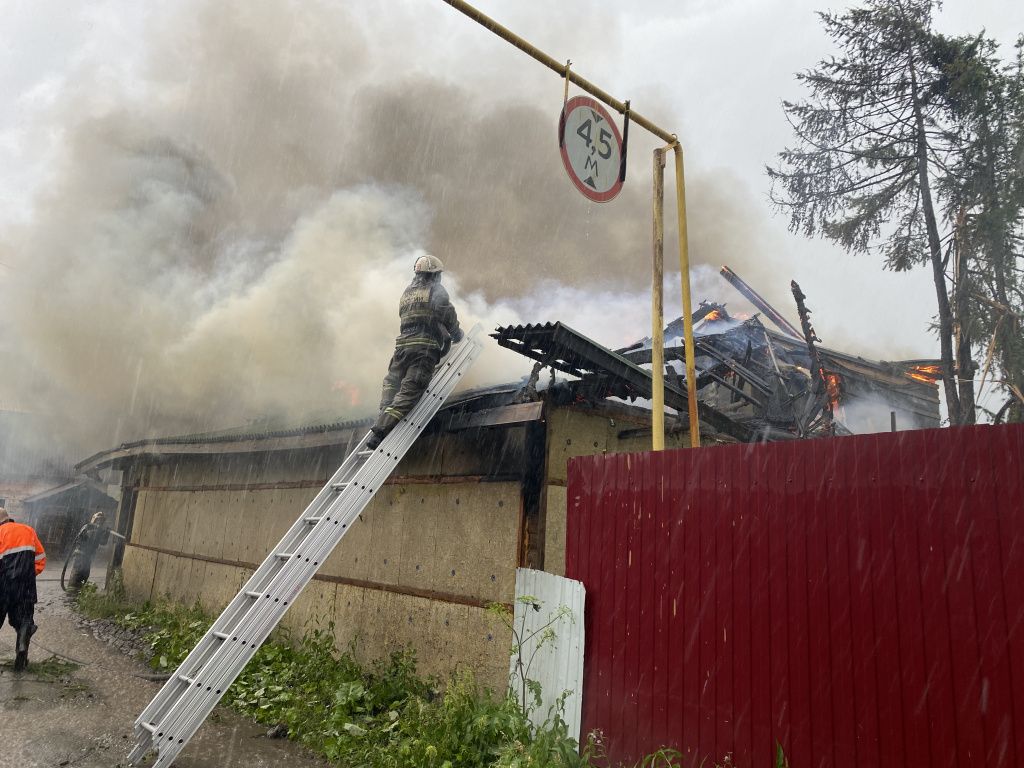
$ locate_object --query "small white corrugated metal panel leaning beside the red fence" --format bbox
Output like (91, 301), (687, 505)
(509, 568), (585, 741)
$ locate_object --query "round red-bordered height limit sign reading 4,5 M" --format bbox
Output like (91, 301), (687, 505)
(558, 96), (623, 203)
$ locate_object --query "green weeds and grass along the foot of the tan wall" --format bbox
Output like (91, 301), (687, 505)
(77, 582), (785, 768)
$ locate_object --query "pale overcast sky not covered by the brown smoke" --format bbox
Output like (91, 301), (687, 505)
(0, 0), (1024, 428)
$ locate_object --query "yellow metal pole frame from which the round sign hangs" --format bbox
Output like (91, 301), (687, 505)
(444, 0), (700, 451)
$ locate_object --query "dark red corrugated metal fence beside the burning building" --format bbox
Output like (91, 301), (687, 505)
(566, 426), (1024, 768)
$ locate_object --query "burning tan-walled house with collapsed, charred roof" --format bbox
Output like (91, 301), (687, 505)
(77, 268), (939, 686)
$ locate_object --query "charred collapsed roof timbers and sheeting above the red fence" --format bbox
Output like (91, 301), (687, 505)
(492, 267), (939, 442)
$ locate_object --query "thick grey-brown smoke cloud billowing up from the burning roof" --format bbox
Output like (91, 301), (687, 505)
(0, 0), (782, 455)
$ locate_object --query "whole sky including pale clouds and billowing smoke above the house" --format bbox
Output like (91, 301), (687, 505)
(0, 0), (1024, 454)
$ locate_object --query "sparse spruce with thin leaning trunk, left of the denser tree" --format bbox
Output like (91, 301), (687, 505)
(768, 0), (974, 424)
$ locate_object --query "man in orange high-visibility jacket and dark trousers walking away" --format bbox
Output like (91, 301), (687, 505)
(0, 507), (46, 672)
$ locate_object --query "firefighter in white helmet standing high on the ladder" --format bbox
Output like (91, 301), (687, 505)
(367, 255), (463, 449)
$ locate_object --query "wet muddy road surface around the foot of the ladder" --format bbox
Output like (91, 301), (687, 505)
(0, 563), (327, 768)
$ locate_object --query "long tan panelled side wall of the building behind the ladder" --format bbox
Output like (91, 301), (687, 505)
(117, 428), (523, 689)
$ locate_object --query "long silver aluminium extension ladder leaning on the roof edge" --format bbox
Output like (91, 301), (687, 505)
(128, 326), (481, 768)
